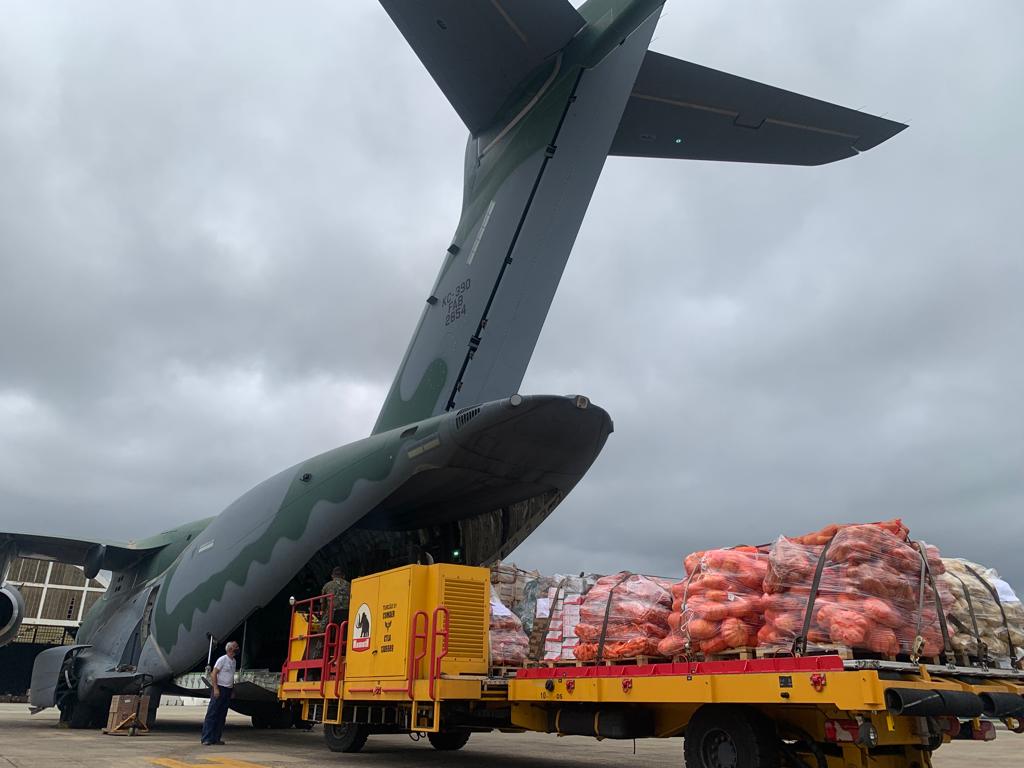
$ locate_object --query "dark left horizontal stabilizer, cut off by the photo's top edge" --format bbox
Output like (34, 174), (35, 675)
(381, 0), (586, 134)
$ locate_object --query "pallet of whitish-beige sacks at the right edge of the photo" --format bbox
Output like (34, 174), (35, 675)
(940, 557), (1024, 660)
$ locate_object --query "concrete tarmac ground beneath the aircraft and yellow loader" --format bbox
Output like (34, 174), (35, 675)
(0, 705), (1024, 768)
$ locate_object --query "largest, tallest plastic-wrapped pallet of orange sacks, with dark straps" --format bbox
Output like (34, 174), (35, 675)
(758, 521), (953, 655)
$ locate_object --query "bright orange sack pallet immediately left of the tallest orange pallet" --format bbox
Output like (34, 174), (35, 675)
(657, 547), (768, 656)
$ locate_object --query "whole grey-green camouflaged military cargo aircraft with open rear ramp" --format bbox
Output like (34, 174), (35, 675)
(0, 0), (905, 726)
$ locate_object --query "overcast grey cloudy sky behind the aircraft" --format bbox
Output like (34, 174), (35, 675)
(0, 0), (1024, 588)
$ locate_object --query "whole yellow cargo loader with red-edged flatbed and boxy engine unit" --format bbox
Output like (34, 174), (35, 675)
(279, 564), (1024, 768)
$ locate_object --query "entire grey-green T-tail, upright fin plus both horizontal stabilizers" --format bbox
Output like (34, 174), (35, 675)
(374, 0), (905, 433)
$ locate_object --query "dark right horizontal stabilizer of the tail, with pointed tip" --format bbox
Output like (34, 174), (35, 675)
(608, 51), (906, 165)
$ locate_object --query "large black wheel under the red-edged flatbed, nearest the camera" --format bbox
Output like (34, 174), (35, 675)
(683, 705), (778, 768)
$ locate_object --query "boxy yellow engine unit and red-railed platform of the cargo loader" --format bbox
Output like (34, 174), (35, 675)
(279, 564), (493, 749)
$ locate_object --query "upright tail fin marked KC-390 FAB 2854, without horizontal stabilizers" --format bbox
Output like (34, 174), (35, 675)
(374, 2), (660, 432)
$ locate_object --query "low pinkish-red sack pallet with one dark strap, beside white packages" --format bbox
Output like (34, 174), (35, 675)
(573, 571), (672, 662)
